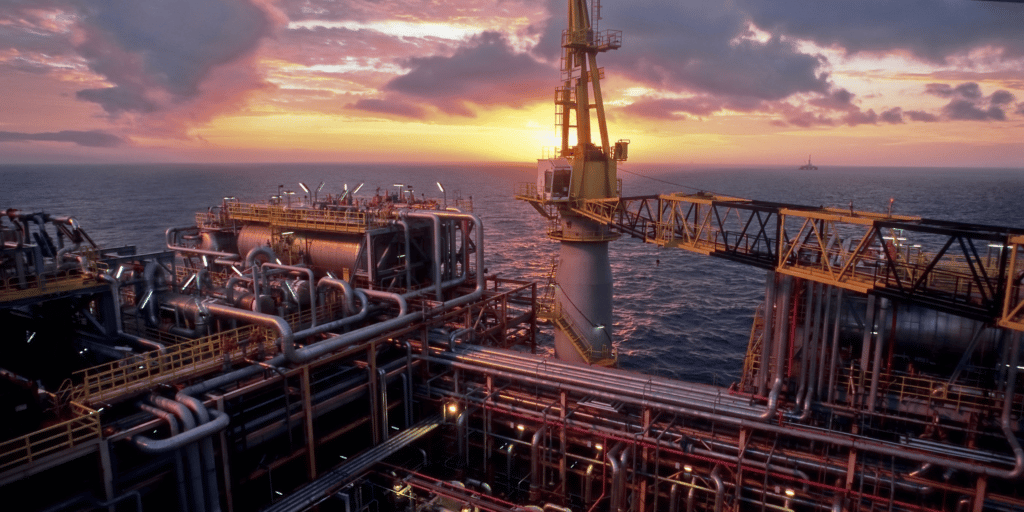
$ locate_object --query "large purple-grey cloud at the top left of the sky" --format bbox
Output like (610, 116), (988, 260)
(77, 0), (272, 116)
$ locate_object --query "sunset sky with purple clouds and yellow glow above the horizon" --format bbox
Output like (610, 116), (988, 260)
(0, 0), (1024, 168)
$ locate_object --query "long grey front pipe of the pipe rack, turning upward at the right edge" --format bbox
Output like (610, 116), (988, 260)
(436, 348), (1024, 479)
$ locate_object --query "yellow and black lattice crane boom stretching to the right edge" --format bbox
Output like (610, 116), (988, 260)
(571, 193), (1024, 331)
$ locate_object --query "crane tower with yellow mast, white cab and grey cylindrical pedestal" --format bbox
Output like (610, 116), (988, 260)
(516, 0), (629, 366)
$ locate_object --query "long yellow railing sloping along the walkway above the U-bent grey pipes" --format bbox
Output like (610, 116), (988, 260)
(72, 326), (276, 403)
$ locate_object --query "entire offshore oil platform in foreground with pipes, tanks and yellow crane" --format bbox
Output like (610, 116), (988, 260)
(0, 0), (1024, 512)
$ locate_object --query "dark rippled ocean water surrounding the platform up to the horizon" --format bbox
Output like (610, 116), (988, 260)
(0, 164), (1024, 384)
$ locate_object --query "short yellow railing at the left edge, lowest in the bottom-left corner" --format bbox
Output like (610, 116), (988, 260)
(0, 401), (101, 473)
